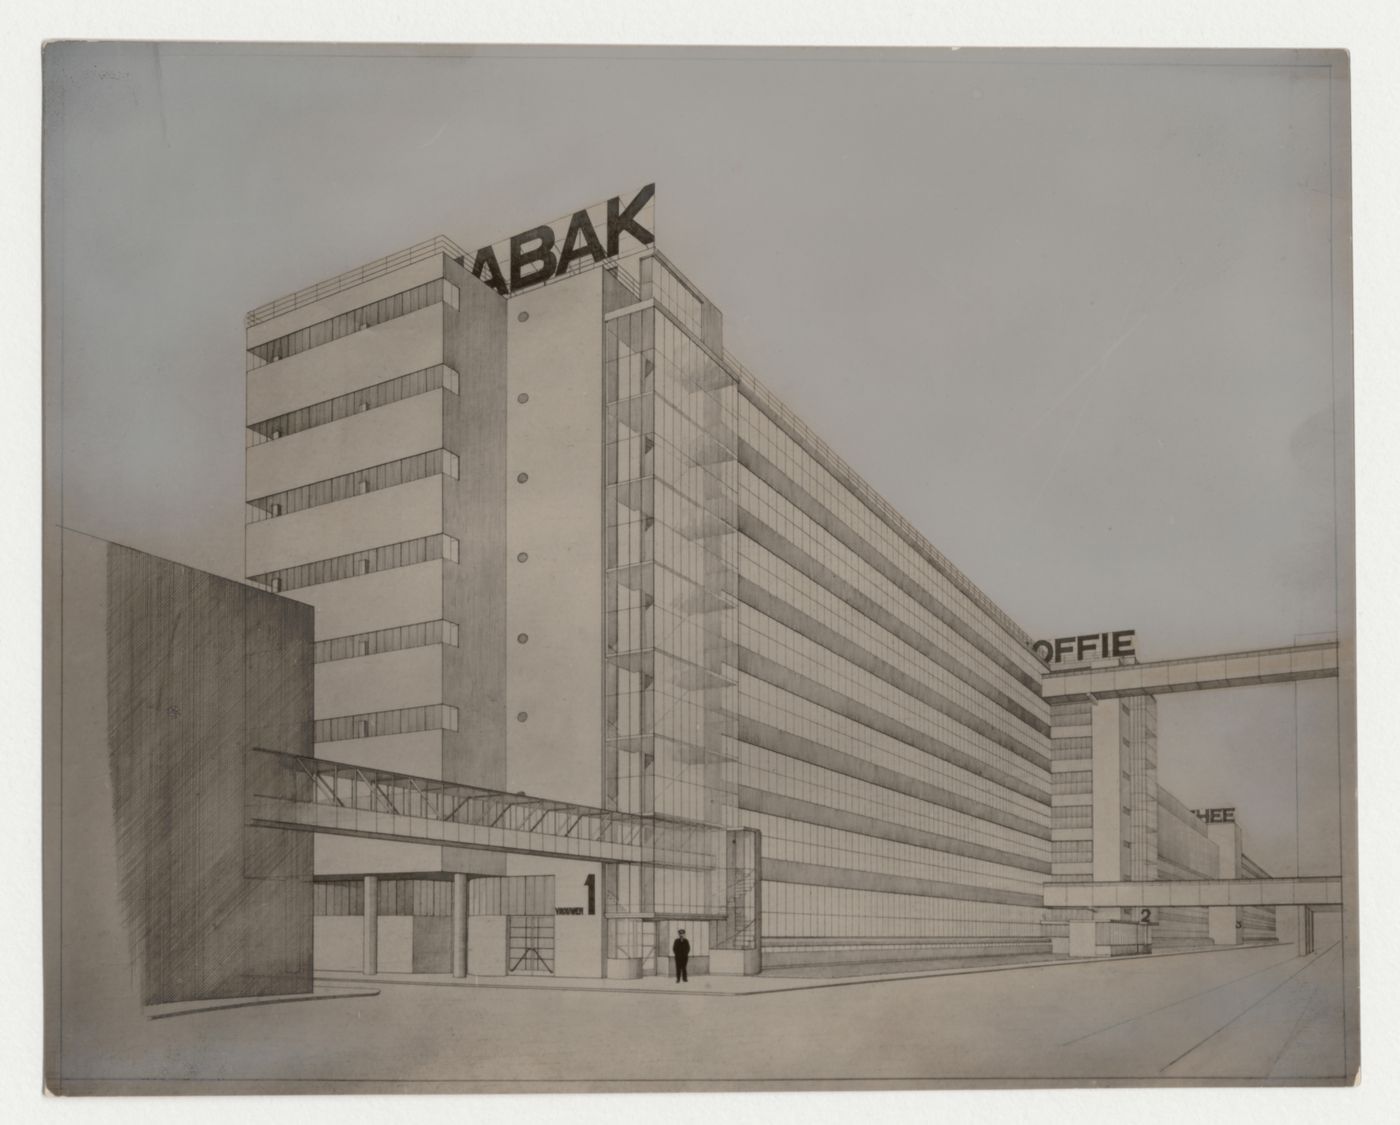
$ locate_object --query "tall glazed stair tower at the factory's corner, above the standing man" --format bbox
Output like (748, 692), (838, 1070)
(603, 256), (738, 971)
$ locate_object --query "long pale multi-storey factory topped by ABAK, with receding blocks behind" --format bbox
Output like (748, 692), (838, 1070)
(245, 186), (1273, 977)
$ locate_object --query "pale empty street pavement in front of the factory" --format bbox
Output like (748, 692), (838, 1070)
(51, 946), (1343, 1089)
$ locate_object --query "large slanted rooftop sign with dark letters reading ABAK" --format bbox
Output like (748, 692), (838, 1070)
(472, 183), (657, 297)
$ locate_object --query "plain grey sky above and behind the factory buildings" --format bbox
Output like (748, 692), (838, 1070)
(45, 43), (1338, 875)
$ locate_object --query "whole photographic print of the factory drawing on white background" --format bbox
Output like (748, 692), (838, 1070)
(43, 42), (1359, 1094)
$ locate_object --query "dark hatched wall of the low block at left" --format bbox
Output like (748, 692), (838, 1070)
(106, 544), (314, 1003)
